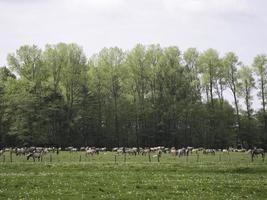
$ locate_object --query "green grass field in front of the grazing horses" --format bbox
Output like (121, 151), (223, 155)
(0, 152), (267, 200)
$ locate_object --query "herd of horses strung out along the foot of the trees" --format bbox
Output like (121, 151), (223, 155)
(0, 146), (265, 161)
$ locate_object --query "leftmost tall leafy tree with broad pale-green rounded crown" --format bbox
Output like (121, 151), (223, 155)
(8, 45), (47, 145)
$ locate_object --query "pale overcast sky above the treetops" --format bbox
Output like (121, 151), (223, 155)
(0, 0), (267, 109)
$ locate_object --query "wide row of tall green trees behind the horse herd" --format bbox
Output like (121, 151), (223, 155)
(0, 43), (267, 148)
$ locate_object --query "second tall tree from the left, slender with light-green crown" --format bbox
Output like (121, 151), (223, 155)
(43, 43), (68, 145)
